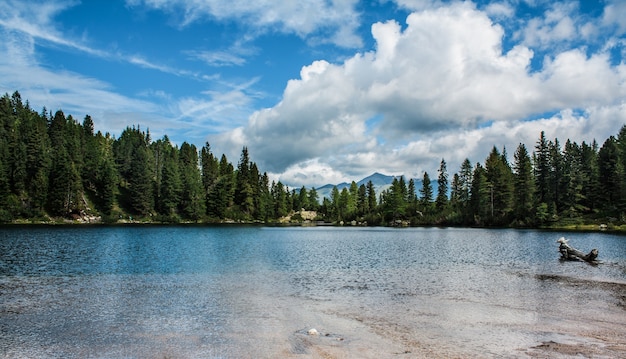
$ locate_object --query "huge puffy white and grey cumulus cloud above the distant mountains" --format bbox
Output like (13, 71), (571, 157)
(212, 3), (626, 188)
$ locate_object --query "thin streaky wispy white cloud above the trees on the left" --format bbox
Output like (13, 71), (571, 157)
(0, 0), (258, 143)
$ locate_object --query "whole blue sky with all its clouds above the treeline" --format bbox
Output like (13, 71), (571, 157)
(0, 0), (626, 188)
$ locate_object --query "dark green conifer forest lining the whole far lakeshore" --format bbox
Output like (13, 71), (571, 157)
(0, 91), (626, 228)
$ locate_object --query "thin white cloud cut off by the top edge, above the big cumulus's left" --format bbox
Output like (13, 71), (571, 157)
(126, 0), (362, 47)
